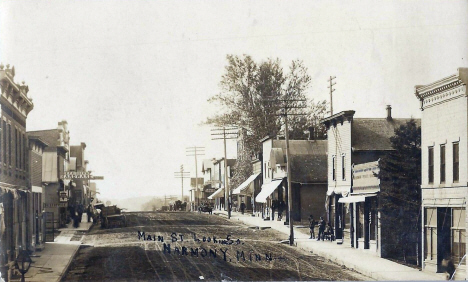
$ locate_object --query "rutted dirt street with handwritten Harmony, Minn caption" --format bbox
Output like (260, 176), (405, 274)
(64, 212), (366, 281)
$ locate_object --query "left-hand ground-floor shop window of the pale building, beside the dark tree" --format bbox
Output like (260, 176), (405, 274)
(424, 208), (437, 260)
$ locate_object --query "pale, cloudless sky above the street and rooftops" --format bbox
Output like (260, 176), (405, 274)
(0, 0), (468, 202)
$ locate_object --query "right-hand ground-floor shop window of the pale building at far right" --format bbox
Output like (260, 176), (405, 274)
(452, 208), (466, 264)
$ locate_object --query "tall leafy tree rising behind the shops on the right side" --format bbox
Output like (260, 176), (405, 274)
(206, 55), (324, 187)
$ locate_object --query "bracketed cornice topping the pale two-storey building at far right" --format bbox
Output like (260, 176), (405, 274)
(414, 68), (468, 111)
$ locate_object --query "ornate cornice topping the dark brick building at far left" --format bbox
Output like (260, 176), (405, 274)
(0, 64), (34, 118)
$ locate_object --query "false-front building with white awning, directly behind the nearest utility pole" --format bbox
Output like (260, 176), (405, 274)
(255, 134), (328, 222)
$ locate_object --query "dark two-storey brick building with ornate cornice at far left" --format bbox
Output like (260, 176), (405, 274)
(0, 65), (33, 277)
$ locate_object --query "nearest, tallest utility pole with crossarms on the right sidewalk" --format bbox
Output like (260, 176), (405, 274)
(269, 95), (307, 246)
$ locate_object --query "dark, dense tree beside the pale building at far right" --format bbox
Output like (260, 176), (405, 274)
(379, 119), (421, 262)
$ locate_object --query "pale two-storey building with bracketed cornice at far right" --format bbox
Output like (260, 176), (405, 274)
(415, 68), (468, 279)
